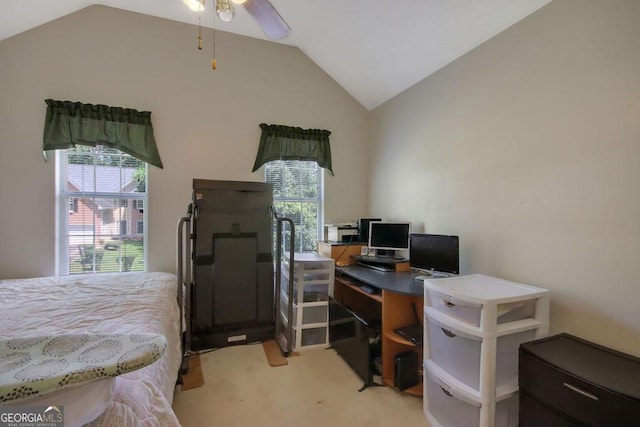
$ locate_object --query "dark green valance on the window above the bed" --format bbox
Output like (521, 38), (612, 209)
(42, 99), (162, 169)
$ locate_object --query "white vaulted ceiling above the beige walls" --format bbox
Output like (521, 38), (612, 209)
(0, 0), (551, 109)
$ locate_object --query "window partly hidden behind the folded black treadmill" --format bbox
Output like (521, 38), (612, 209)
(265, 160), (323, 252)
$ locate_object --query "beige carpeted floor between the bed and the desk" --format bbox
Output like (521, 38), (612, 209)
(173, 344), (429, 427)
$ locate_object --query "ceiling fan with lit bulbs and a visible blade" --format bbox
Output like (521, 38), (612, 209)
(183, 0), (291, 40)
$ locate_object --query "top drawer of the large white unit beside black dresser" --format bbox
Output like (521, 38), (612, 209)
(426, 289), (536, 327)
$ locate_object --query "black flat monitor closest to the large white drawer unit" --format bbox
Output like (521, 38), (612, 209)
(409, 233), (460, 274)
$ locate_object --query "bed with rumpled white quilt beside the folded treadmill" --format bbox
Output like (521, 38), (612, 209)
(0, 273), (181, 427)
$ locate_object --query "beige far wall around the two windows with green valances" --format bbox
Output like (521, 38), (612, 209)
(0, 6), (368, 278)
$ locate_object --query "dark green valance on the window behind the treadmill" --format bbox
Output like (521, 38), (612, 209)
(252, 123), (333, 175)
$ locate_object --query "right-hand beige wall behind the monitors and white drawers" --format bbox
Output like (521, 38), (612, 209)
(370, 0), (640, 355)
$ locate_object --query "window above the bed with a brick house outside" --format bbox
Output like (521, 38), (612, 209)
(56, 146), (148, 275)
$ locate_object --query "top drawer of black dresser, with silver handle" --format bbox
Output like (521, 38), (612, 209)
(519, 351), (640, 426)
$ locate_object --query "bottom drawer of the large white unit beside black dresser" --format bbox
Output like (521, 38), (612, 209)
(424, 367), (518, 427)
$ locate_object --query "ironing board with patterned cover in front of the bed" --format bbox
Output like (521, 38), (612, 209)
(0, 334), (167, 402)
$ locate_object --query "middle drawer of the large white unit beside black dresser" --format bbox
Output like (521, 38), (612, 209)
(425, 310), (535, 391)
